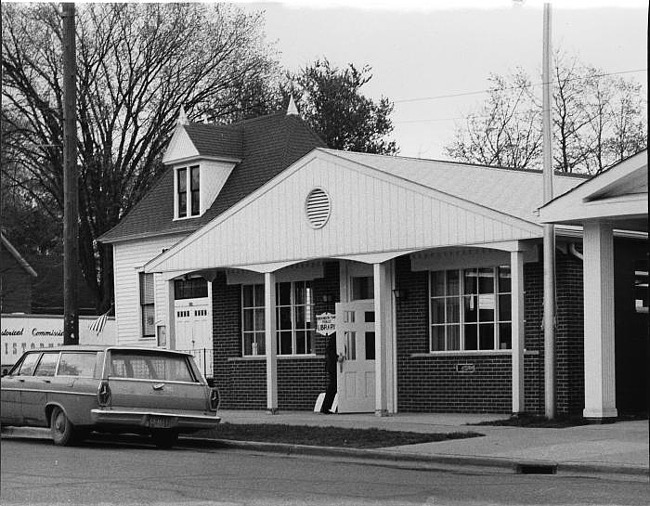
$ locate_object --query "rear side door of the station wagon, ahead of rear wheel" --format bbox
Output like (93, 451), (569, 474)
(21, 351), (59, 427)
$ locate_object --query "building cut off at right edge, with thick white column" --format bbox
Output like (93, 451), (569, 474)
(540, 151), (648, 418)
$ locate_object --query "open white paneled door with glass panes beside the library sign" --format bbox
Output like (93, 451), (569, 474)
(336, 300), (376, 413)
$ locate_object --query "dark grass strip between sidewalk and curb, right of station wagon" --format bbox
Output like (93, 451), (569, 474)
(195, 423), (483, 448)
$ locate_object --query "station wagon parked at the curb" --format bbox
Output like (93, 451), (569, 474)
(0, 346), (221, 447)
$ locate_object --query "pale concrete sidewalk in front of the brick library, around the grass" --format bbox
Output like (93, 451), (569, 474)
(2, 410), (649, 480)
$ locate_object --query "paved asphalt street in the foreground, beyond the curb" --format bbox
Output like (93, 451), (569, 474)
(0, 439), (650, 505)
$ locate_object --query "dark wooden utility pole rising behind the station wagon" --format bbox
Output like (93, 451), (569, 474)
(61, 3), (79, 344)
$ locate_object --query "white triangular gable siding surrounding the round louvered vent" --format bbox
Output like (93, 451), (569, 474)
(147, 151), (541, 271)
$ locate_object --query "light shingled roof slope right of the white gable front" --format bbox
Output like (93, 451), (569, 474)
(324, 149), (588, 223)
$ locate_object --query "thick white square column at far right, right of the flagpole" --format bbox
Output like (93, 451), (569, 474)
(583, 221), (618, 418)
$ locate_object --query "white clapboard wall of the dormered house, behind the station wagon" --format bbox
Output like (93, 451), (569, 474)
(113, 236), (183, 346)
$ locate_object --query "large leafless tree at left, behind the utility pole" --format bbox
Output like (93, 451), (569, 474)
(2, 3), (279, 311)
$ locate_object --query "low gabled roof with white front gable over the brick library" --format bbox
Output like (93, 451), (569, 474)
(145, 149), (581, 272)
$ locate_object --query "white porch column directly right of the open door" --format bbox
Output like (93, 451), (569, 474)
(373, 262), (395, 416)
